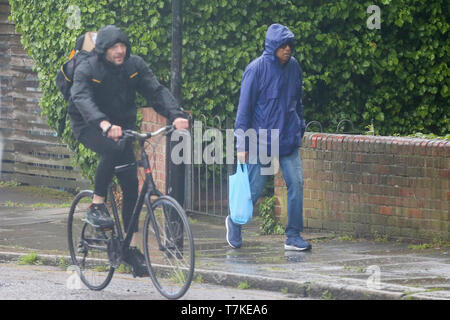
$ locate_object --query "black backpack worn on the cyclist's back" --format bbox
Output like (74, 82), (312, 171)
(56, 34), (93, 101)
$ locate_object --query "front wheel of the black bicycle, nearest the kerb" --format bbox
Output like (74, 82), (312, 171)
(143, 196), (195, 299)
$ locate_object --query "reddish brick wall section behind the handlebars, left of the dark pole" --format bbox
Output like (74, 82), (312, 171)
(139, 108), (166, 193)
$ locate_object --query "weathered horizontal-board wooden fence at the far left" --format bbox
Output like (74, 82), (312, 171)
(0, 0), (90, 190)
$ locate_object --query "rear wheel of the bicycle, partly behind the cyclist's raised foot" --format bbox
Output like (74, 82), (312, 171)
(67, 190), (114, 290)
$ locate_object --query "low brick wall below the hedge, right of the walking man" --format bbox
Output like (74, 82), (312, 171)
(275, 133), (450, 240)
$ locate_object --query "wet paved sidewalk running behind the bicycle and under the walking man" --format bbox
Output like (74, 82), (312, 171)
(0, 187), (450, 299)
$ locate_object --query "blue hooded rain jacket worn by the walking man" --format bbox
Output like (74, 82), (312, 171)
(234, 24), (305, 156)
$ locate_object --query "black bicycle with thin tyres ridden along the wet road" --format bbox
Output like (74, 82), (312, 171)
(68, 126), (195, 299)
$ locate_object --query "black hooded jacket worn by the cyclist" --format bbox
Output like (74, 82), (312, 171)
(68, 25), (186, 138)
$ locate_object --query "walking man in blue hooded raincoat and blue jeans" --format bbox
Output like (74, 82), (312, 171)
(225, 24), (311, 251)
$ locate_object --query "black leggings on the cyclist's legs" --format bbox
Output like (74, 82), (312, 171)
(78, 127), (139, 232)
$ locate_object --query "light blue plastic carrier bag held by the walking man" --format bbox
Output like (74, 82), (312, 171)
(228, 161), (253, 224)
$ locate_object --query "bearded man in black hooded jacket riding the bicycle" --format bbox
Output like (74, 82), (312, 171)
(68, 25), (189, 276)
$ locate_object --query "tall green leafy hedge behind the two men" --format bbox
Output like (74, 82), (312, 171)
(10, 0), (450, 177)
